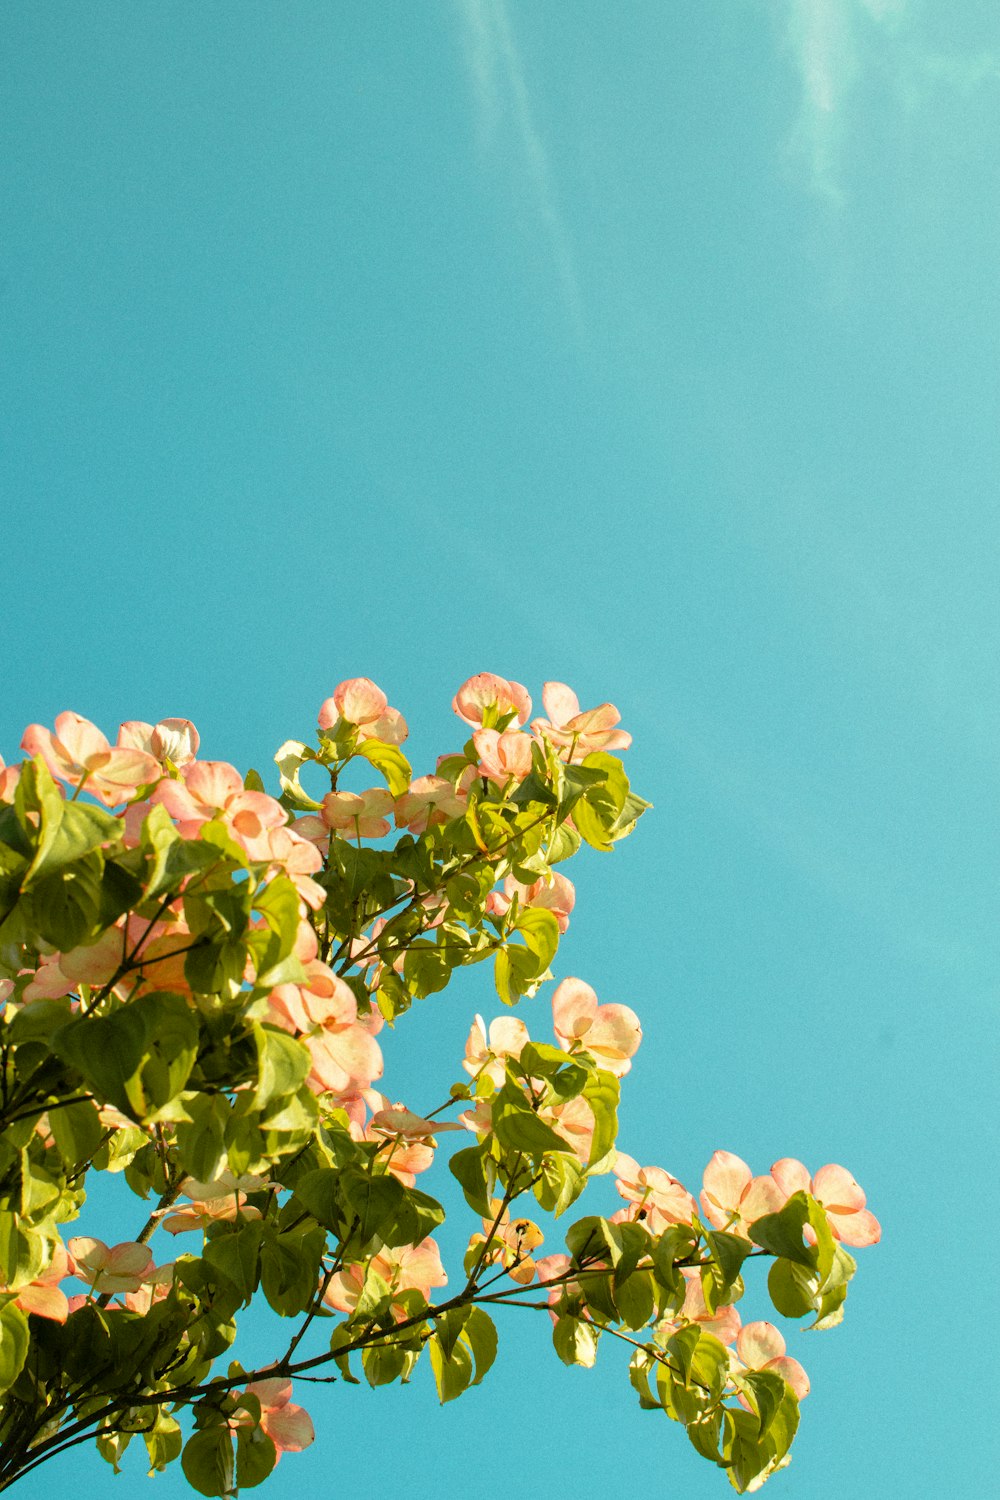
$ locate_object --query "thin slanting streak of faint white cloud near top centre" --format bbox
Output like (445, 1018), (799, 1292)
(456, 0), (583, 335)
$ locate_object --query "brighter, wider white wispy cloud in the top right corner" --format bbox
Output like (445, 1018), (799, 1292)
(777, 0), (1000, 207)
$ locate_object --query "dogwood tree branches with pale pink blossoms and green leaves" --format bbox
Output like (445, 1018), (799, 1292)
(0, 674), (879, 1496)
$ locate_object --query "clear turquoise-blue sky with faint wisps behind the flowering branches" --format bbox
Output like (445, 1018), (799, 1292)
(0, 0), (1000, 1500)
